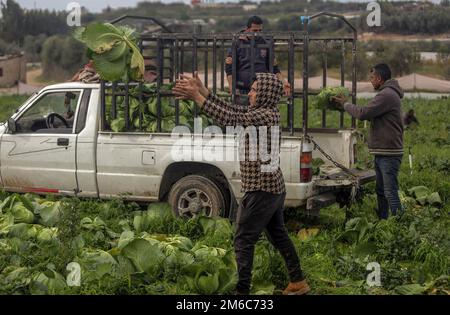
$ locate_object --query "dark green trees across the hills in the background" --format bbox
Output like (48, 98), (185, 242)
(0, 0), (450, 80)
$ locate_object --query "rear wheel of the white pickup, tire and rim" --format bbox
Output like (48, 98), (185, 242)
(168, 175), (226, 217)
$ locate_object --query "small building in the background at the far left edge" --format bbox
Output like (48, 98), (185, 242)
(0, 54), (27, 88)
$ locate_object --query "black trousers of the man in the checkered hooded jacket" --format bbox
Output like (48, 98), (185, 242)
(234, 191), (304, 294)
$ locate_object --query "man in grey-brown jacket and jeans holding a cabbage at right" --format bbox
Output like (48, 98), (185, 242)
(334, 63), (403, 219)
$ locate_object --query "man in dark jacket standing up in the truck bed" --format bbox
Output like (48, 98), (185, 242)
(225, 16), (291, 105)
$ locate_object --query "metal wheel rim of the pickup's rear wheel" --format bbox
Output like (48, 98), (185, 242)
(178, 188), (213, 217)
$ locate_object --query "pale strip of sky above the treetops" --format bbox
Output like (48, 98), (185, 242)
(10, 0), (439, 12)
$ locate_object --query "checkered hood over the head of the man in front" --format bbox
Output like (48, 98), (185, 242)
(254, 73), (284, 108)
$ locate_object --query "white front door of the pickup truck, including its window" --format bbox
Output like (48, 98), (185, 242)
(0, 89), (83, 195)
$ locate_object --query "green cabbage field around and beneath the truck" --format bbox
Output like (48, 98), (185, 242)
(0, 97), (450, 295)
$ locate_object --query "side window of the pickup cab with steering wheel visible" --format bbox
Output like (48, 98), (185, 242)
(17, 91), (80, 134)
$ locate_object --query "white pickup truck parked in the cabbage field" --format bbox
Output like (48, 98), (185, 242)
(0, 83), (373, 218)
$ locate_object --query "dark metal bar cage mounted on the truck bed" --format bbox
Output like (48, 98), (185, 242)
(101, 12), (357, 135)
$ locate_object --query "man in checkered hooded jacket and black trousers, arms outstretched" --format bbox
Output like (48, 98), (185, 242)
(173, 73), (310, 295)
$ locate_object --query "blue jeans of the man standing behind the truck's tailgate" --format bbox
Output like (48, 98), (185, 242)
(375, 155), (403, 219)
